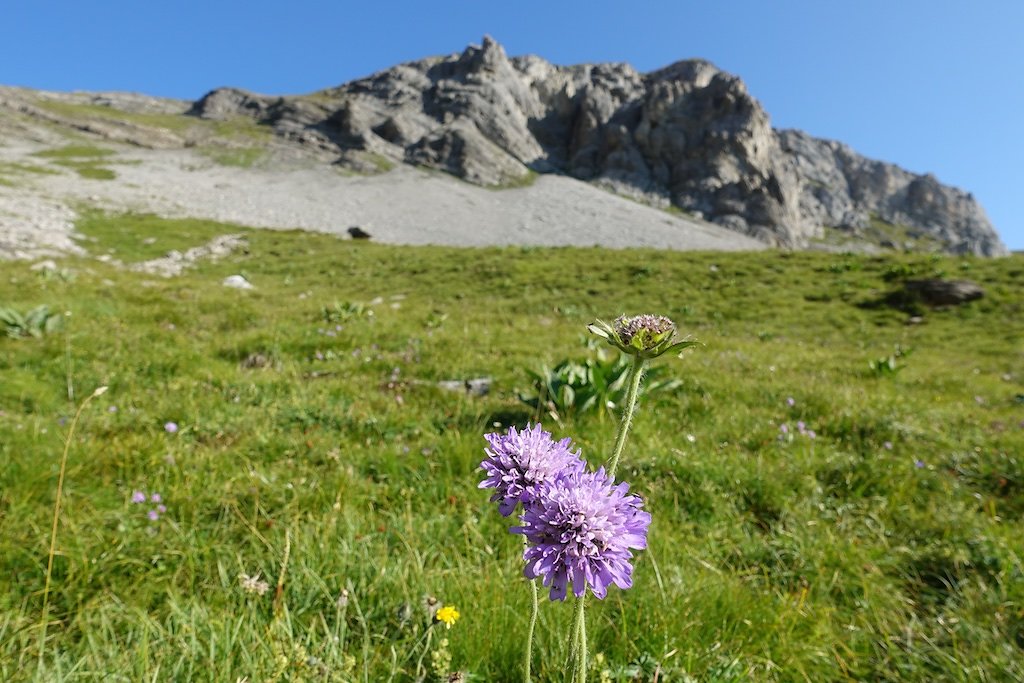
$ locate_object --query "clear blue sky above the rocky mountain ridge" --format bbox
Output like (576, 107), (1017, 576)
(0, 0), (1024, 249)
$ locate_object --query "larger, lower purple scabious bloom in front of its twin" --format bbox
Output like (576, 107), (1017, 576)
(510, 467), (650, 600)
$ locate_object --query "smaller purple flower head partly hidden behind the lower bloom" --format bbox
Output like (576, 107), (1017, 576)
(479, 425), (586, 517)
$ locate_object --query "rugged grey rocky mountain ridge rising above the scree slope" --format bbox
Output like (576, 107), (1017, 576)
(190, 37), (1002, 254)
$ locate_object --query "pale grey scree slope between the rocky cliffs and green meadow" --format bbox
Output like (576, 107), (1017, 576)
(0, 143), (765, 258)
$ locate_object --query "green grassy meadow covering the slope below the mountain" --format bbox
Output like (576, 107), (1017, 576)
(0, 211), (1024, 683)
